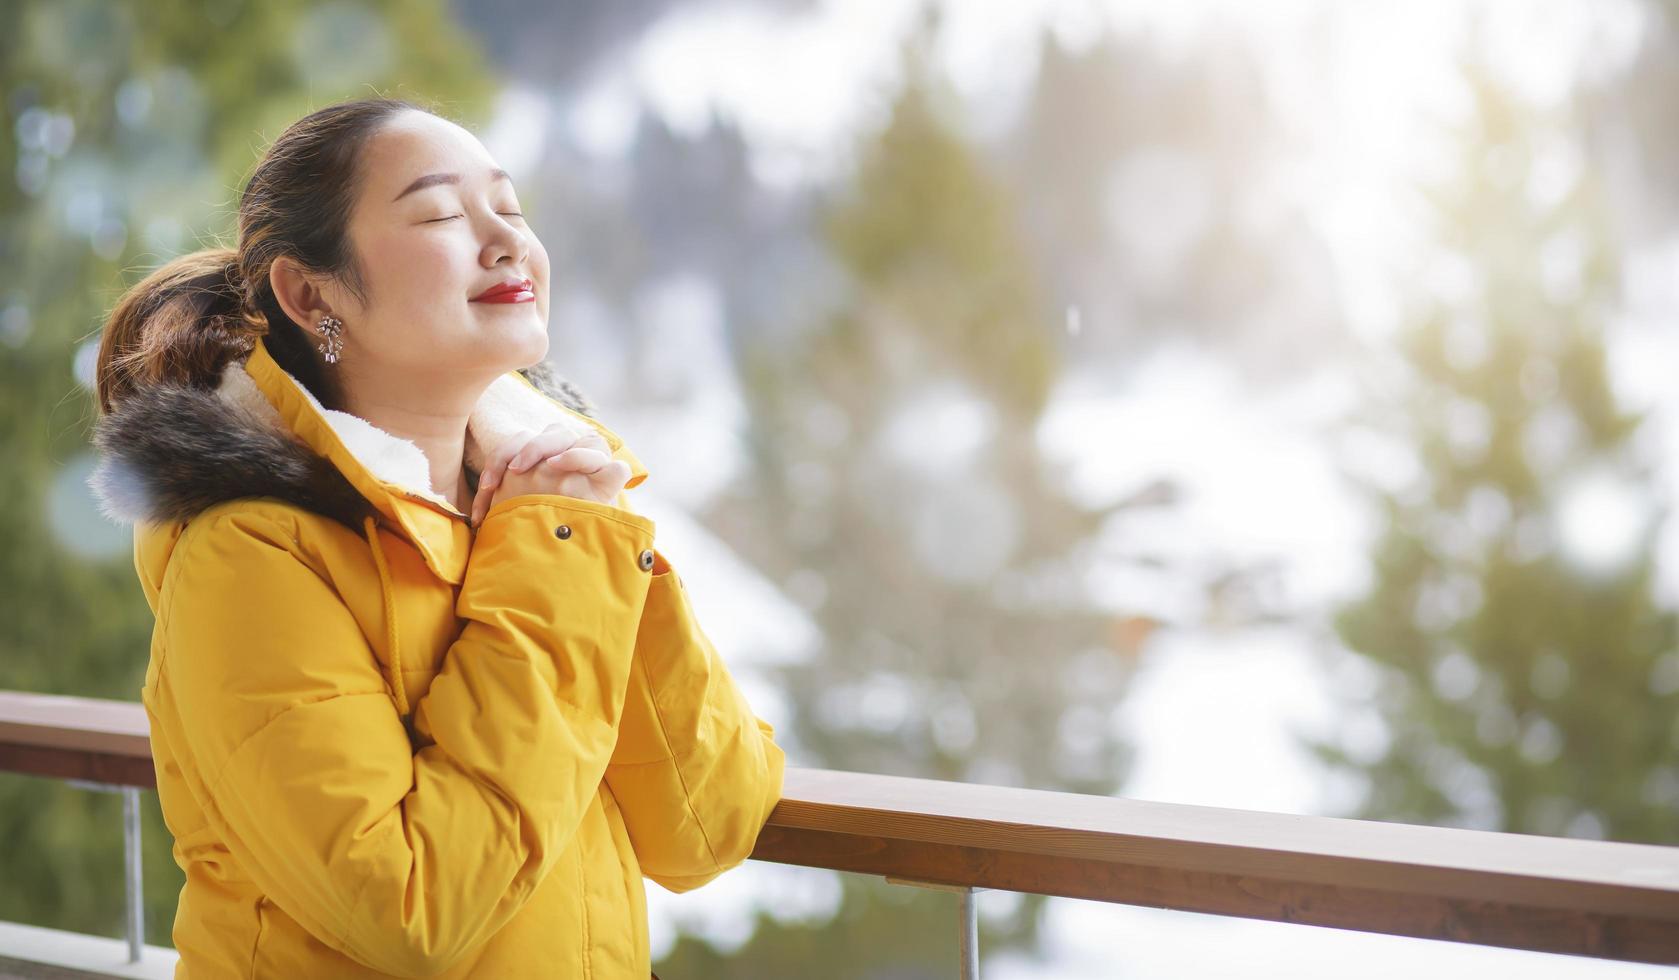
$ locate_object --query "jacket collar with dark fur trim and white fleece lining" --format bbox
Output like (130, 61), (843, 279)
(89, 332), (648, 584)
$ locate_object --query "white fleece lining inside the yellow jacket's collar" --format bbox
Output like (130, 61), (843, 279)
(217, 361), (588, 507)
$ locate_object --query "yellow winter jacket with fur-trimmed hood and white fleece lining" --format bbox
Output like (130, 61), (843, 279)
(94, 335), (784, 980)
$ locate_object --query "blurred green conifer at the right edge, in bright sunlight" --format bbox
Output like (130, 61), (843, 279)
(1315, 72), (1679, 844)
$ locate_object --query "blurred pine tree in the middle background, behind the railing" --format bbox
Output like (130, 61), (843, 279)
(656, 11), (1130, 978)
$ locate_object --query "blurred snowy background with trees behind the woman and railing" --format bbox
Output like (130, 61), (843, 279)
(0, 0), (1679, 980)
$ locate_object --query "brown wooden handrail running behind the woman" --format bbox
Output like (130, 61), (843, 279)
(0, 691), (1679, 963)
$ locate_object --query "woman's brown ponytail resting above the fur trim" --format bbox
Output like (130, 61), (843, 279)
(94, 248), (269, 416)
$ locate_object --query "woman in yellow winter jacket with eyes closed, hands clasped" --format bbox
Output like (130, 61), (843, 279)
(80, 99), (784, 980)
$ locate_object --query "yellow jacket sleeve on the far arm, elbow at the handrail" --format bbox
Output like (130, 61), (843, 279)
(606, 549), (786, 893)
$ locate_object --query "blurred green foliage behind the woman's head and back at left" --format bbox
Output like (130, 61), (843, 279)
(0, 0), (494, 945)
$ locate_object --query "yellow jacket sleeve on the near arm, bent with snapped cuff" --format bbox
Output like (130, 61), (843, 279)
(158, 495), (653, 977)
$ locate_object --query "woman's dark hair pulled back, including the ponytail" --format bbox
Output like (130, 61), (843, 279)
(94, 97), (440, 416)
